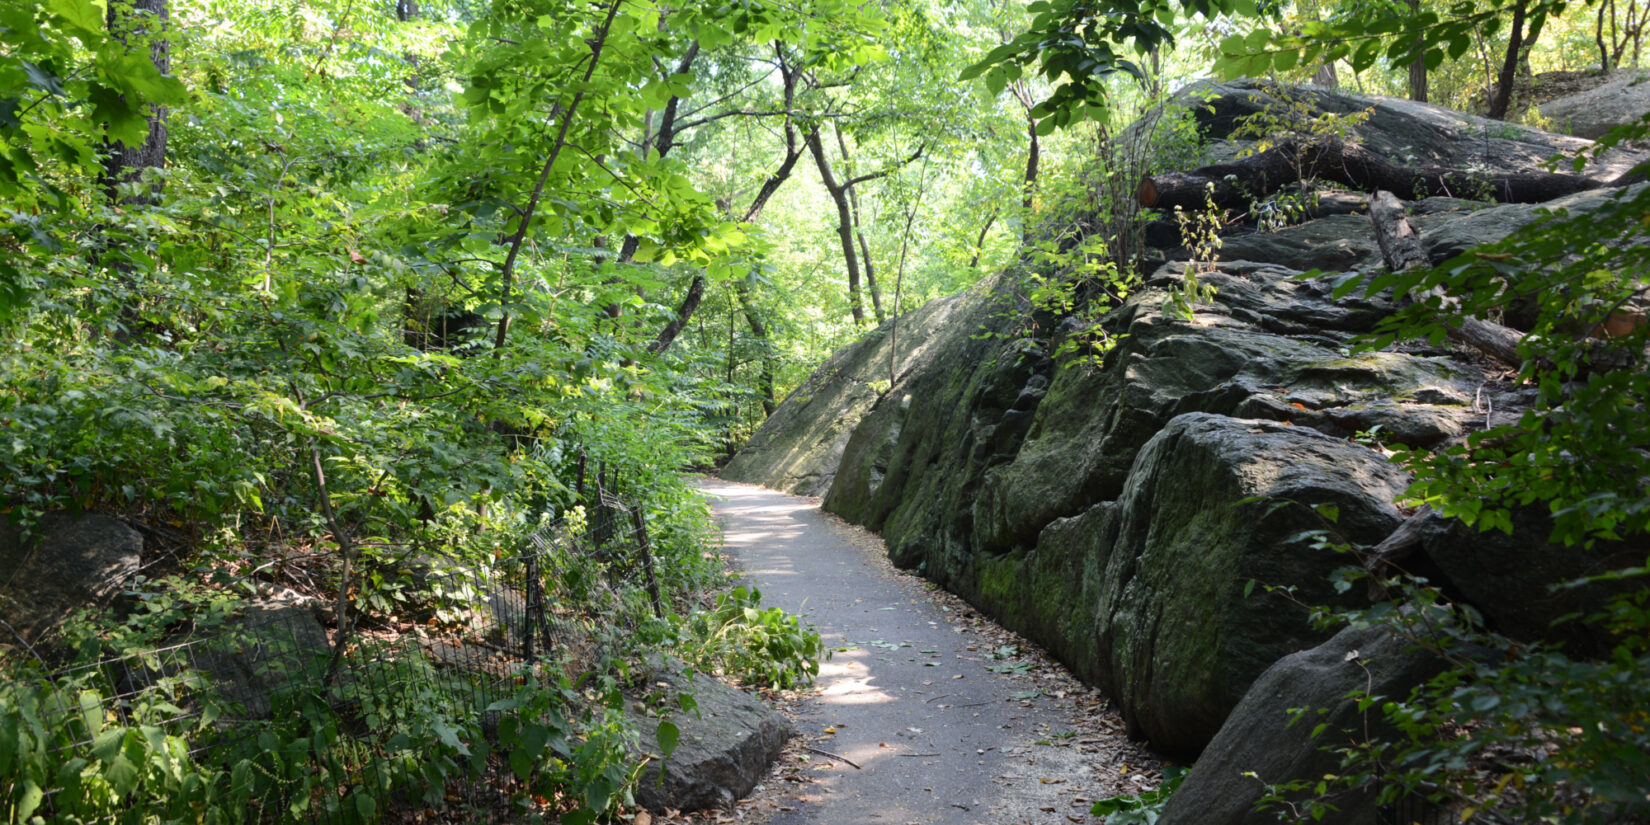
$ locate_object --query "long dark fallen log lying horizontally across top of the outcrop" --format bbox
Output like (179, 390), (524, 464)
(1137, 140), (1607, 211)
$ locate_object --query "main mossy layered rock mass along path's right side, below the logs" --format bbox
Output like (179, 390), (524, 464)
(825, 262), (1483, 754)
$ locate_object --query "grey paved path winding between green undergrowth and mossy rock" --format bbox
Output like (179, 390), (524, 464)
(701, 480), (1157, 825)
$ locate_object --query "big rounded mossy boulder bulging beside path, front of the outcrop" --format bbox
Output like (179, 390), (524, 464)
(959, 413), (1407, 757)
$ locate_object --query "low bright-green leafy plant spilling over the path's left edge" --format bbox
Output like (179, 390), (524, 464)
(686, 586), (830, 690)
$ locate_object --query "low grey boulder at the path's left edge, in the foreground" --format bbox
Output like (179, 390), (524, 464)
(629, 668), (792, 812)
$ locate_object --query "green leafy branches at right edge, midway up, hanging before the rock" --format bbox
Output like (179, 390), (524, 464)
(1337, 144), (1650, 545)
